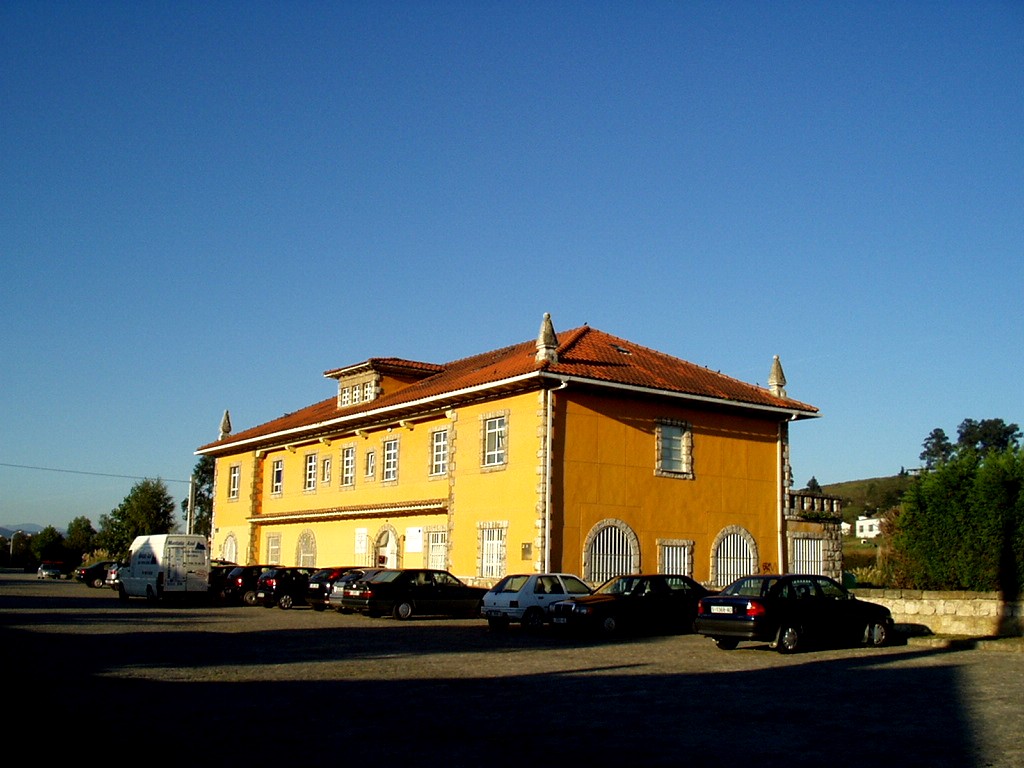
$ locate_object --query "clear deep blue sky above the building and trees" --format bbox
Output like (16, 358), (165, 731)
(0, 0), (1024, 527)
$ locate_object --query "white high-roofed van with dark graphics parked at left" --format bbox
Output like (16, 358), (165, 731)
(118, 534), (210, 600)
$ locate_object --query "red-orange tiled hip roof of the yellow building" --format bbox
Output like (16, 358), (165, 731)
(197, 326), (817, 454)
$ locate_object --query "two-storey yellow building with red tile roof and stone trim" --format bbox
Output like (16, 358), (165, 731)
(197, 315), (841, 586)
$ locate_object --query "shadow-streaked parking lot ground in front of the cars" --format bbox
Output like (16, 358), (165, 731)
(0, 572), (1024, 768)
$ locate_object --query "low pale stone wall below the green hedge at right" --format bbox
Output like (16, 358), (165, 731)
(853, 589), (1024, 637)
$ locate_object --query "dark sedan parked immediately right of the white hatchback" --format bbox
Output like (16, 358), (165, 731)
(552, 573), (710, 634)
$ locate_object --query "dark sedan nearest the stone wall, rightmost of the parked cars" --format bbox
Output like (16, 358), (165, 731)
(696, 573), (893, 653)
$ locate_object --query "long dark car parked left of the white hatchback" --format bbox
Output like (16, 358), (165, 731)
(342, 568), (487, 620)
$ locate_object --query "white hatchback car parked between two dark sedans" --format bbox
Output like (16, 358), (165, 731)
(480, 573), (593, 630)
